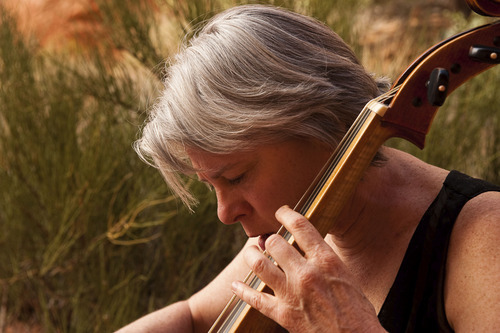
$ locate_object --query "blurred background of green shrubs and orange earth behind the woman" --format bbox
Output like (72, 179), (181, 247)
(0, 0), (500, 333)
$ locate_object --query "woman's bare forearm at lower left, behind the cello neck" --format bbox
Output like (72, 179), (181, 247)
(117, 239), (257, 333)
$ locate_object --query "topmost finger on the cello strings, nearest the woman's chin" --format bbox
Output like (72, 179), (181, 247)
(276, 206), (331, 256)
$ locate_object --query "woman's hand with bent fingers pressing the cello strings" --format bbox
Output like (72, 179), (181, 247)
(233, 206), (383, 333)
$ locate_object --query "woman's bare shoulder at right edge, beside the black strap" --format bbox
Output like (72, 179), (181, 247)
(445, 192), (500, 331)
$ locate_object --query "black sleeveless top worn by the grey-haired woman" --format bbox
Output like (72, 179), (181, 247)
(378, 171), (500, 333)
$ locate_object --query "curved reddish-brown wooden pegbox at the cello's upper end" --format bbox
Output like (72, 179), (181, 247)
(383, 22), (500, 148)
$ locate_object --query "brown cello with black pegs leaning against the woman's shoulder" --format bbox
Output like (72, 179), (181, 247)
(209, 0), (500, 332)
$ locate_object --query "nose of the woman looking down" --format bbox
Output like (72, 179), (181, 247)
(216, 190), (250, 225)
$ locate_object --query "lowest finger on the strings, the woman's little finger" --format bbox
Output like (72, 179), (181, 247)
(231, 281), (276, 320)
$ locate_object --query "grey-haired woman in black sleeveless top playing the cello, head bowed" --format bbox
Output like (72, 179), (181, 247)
(118, 5), (500, 332)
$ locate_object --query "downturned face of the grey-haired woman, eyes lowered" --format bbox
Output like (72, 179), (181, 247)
(188, 139), (331, 237)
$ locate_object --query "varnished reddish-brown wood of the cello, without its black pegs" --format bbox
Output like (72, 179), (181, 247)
(211, 7), (500, 333)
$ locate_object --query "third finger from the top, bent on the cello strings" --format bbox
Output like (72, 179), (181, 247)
(243, 246), (286, 292)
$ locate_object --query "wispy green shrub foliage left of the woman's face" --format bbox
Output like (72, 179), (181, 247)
(0, 1), (244, 332)
